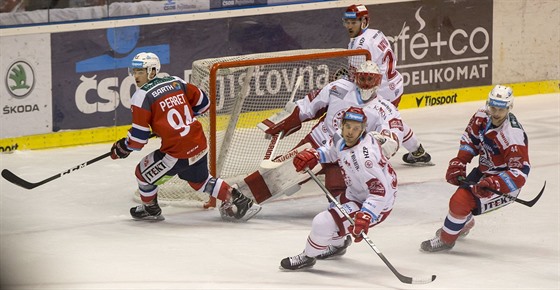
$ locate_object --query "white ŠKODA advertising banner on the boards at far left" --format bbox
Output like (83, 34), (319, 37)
(0, 34), (52, 138)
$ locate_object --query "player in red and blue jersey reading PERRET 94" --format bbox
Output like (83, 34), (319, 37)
(111, 52), (260, 220)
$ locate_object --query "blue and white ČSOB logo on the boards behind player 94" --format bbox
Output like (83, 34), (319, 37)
(74, 26), (170, 114)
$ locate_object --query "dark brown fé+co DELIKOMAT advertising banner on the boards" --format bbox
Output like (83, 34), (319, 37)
(368, 0), (493, 95)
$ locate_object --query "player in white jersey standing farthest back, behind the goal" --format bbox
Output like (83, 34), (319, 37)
(342, 4), (432, 165)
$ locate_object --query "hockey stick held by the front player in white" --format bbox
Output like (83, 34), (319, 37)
(305, 168), (436, 284)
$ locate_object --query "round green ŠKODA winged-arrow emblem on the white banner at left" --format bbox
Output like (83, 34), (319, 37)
(6, 61), (35, 99)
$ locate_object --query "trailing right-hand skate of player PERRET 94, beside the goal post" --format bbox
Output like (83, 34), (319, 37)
(220, 188), (262, 221)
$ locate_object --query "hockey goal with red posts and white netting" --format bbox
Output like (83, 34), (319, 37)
(136, 49), (370, 207)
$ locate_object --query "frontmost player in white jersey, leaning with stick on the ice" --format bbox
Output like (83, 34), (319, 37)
(280, 107), (397, 270)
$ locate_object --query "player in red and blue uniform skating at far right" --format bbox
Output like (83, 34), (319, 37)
(420, 85), (531, 252)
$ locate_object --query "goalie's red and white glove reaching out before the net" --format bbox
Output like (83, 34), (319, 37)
(257, 102), (301, 138)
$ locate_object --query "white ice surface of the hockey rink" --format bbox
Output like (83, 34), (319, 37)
(0, 94), (560, 290)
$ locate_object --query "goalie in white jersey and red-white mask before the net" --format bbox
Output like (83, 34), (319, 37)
(252, 61), (403, 203)
